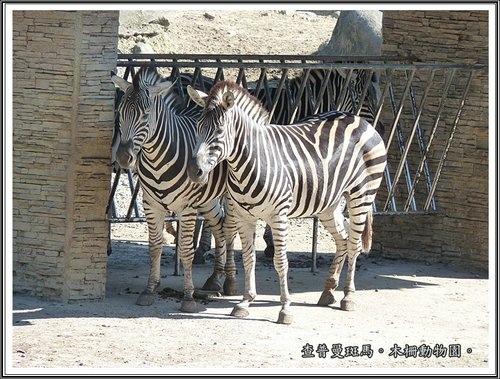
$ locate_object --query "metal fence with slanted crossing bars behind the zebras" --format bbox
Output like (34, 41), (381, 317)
(107, 54), (484, 270)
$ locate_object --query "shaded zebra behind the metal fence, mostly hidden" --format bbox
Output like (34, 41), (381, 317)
(254, 69), (384, 257)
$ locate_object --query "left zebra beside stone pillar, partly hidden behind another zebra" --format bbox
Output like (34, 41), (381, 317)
(112, 67), (237, 312)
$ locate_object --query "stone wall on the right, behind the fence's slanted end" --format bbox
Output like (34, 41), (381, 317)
(374, 11), (489, 271)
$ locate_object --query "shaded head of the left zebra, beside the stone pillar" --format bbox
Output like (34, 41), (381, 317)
(111, 66), (173, 169)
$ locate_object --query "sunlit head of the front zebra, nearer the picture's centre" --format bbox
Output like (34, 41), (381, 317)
(187, 82), (239, 183)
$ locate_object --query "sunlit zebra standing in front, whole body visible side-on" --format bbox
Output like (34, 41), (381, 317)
(188, 81), (386, 324)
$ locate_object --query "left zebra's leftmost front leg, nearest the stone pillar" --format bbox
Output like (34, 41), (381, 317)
(135, 203), (165, 305)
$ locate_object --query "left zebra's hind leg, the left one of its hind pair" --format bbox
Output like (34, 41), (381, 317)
(199, 199), (226, 292)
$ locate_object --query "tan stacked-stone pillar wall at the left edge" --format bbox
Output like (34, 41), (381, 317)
(13, 11), (119, 301)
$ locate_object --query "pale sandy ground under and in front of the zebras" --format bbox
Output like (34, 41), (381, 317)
(12, 238), (493, 374)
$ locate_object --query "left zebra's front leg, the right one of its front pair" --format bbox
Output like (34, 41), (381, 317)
(177, 209), (197, 313)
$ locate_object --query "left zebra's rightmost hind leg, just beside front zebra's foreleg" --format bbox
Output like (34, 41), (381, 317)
(224, 200), (239, 296)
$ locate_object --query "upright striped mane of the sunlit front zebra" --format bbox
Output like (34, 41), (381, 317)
(206, 80), (270, 124)
